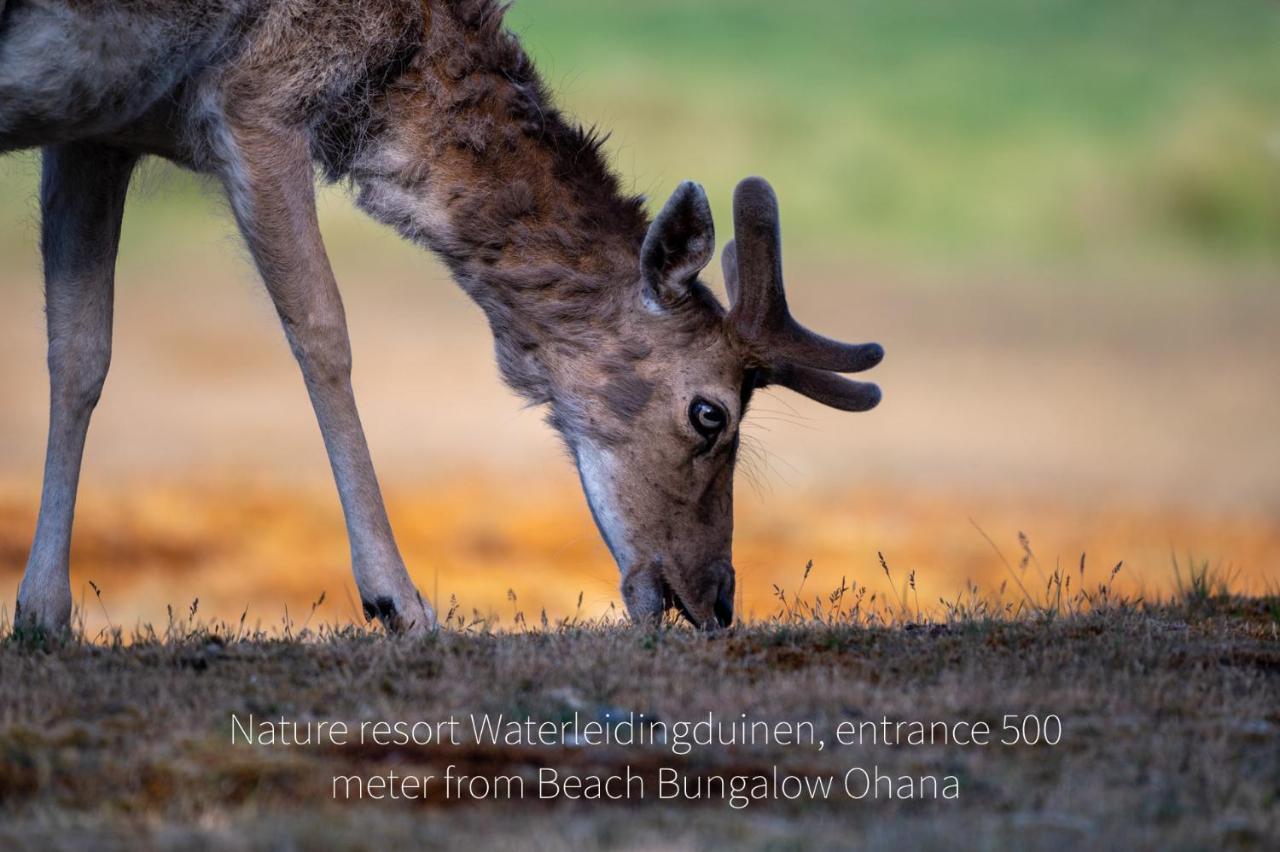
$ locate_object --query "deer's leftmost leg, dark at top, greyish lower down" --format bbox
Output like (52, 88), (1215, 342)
(14, 143), (136, 632)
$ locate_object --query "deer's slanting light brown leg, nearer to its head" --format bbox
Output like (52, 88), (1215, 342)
(223, 122), (435, 632)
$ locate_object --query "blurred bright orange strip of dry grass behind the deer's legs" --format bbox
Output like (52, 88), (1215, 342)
(0, 476), (1280, 636)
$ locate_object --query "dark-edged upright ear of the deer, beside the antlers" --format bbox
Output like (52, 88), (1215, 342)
(640, 180), (716, 306)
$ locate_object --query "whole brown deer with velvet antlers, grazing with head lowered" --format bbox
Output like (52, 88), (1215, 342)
(0, 0), (883, 629)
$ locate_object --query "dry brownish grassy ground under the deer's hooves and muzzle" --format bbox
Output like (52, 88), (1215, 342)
(0, 590), (1280, 849)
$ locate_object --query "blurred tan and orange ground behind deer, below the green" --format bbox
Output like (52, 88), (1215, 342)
(0, 228), (1280, 627)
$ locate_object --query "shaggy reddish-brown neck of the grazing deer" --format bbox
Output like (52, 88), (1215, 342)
(351, 13), (648, 402)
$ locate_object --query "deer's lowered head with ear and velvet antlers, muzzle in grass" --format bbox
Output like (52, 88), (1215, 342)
(552, 178), (883, 628)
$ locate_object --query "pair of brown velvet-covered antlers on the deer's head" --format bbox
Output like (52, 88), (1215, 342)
(722, 178), (884, 411)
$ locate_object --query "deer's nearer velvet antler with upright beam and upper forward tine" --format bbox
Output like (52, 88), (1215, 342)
(723, 178), (884, 372)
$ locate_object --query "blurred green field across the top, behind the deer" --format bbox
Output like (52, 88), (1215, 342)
(0, 0), (1280, 271)
